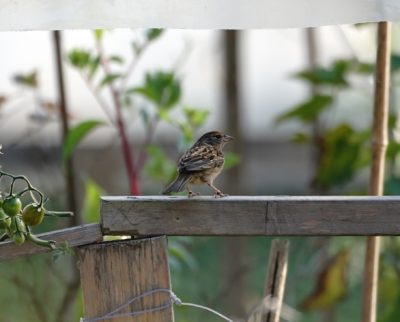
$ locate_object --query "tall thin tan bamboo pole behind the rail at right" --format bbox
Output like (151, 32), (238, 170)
(362, 22), (391, 322)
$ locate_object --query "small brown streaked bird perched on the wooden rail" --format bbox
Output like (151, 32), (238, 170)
(162, 131), (233, 198)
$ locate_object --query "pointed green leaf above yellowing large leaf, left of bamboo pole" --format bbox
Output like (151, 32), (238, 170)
(276, 94), (333, 123)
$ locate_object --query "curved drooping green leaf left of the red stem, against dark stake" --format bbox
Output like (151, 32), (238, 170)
(62, 120), (105, 162)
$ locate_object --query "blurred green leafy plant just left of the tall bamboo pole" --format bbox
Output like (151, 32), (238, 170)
(276, 59), (374, 192)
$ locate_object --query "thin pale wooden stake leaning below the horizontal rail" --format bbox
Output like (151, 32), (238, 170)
(261, 239), (289, 322)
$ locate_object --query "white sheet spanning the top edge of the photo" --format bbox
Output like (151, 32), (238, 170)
(0, 0), (400, 30)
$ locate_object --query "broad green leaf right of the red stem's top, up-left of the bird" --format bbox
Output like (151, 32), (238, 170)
(134, 71), (181, 109)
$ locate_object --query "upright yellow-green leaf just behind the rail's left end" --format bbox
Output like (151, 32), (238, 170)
(82, 179), (104, 223)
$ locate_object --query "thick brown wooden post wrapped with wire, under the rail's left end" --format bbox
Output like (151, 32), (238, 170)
(78, 236), (174, 322)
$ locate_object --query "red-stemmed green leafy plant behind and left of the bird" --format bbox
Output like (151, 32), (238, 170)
(63, 29), (208, 195)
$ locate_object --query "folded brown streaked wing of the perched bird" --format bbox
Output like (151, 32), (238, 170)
(178, 145), (224, 173)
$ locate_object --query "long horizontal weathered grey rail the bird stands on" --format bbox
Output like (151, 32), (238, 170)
(101, 196), (400, 236)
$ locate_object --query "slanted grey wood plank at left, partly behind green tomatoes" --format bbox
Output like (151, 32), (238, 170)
(0, 224), (103, 261)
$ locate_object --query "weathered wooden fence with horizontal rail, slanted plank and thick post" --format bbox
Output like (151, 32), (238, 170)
(0, 196), (400, 322)
